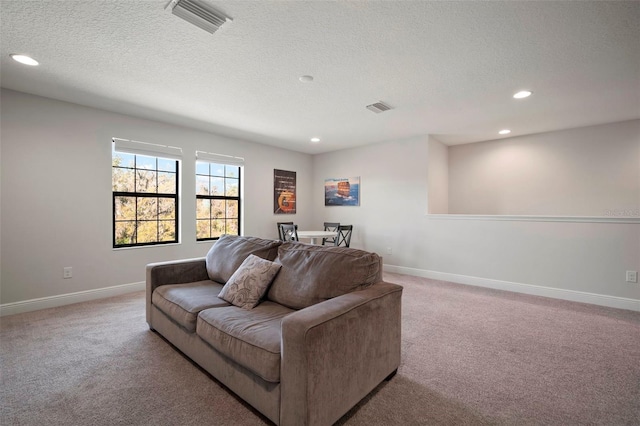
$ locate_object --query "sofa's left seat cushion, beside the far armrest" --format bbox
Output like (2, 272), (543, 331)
(151, 280), (229, 333)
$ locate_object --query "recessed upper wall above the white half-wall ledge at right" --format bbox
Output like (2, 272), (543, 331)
(449, 120), (640, 216)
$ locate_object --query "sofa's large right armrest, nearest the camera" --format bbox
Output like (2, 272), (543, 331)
(280, 282), (402, 426)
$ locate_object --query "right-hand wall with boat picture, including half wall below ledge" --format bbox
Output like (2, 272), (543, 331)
(312, 133), (640, 310)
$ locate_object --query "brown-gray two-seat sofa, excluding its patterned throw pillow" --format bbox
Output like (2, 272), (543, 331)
(146, 235), (402, 426)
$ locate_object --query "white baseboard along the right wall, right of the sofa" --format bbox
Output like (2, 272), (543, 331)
(384, 264), (640, 311)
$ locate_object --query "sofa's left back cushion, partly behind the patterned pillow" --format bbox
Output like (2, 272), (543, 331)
(206, 235), (282, 284)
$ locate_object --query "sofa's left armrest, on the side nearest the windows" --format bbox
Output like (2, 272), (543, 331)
(146, 257), (209, 325)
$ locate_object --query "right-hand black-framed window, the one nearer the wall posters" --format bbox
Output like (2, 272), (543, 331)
(196, 160), (241, 241)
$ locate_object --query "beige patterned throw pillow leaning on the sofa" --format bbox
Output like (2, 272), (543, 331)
(218, 254), (282, 310)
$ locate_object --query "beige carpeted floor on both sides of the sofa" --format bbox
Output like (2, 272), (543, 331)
(0, 273), (640, 426)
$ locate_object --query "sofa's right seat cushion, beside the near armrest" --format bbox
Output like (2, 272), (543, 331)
(196, 301), (294, 383)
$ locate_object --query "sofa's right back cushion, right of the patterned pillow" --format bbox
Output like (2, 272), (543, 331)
(267, 242), (382, 309)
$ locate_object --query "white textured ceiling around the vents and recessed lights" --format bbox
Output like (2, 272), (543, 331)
(0, 0), (640, 153)
